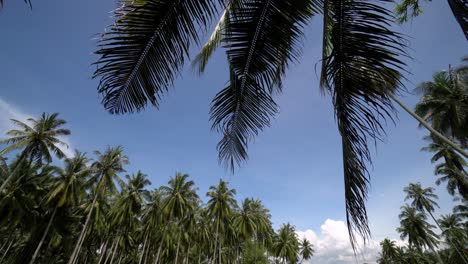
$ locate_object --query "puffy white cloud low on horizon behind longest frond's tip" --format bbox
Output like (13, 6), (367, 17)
(297, 219), (401, 264)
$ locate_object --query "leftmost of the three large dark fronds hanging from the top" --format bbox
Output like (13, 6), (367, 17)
(94, 0), (221, 114)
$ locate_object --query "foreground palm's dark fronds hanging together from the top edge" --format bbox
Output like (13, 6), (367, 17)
(94, 0), (468, 245)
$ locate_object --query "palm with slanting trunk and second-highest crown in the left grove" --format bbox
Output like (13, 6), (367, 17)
(68, 146), (128, 264)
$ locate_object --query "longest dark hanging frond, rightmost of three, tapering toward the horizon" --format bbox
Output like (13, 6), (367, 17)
(322, 0), (404, 247)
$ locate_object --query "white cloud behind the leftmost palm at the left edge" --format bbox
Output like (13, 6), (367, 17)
(0, 97), (73, 157)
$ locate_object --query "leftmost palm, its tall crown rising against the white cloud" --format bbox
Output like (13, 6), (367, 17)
(0, 113), (70, 193)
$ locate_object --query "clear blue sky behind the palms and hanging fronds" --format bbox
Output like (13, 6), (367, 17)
(0, 0), (468, 263)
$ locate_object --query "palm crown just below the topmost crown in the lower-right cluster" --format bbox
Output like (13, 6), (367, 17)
(397, 205), (437, 251)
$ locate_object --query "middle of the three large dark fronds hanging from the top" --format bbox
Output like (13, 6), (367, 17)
(211, 0), (314, 169)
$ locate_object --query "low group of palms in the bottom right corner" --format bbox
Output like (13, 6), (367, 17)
(378, 183), (468, 264)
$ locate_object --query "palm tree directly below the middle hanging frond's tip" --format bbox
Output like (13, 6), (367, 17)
(206, 180), (237, 264)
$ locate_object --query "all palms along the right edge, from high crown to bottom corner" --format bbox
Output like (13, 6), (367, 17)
(379, 58), (468, 264)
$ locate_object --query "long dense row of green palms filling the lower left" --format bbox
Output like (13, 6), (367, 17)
(0, 114), (313, 264)
